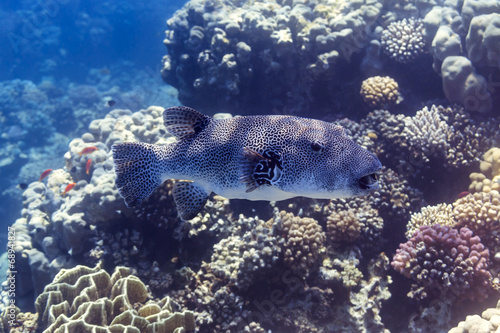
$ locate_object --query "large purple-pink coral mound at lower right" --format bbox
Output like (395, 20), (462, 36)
(391, 224), (491, 300)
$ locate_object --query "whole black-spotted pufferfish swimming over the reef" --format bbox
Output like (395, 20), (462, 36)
(112, 106), (382, 220)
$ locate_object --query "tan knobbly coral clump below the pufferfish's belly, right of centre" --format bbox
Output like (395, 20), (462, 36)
(274, 211), (325, 277)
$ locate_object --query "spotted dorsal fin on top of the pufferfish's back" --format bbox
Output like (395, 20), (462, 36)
(163, 106), (212, 140)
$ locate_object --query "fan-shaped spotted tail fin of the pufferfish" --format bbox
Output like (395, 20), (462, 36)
(112, 142), (163, 207)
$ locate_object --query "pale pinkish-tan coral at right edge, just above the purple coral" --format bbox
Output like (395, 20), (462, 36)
(453, 190), (500, 250)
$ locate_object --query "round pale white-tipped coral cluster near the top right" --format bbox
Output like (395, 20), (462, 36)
(381, 17), (426, 63)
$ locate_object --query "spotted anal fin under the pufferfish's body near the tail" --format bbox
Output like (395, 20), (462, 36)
(172, 181), (210, 221)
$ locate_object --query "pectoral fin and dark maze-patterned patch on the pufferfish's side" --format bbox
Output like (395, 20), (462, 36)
(240, 147), (283, 193)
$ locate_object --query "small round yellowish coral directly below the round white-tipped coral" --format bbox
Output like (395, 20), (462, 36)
(360, 76), (401, 109)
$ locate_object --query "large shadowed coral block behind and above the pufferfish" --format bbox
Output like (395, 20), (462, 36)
(162, 0), (382, 112)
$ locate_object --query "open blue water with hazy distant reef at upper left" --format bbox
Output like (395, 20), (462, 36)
(0, 0), (184, 248)
